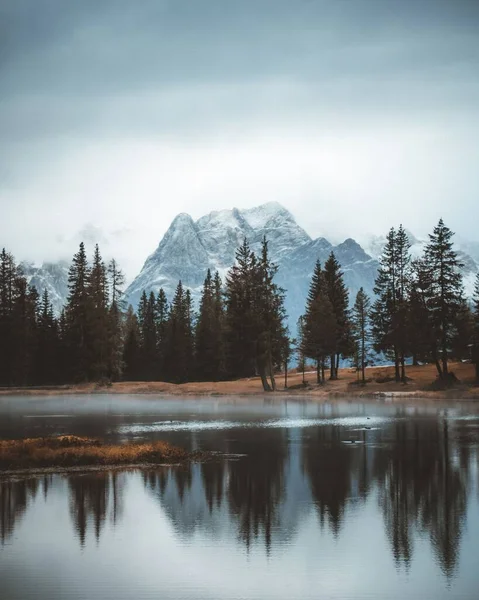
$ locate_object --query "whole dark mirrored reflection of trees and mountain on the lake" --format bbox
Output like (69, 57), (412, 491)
(0, 417), (479, 578)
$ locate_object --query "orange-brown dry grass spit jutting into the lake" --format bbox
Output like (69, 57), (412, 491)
(0, 435), (191, 470)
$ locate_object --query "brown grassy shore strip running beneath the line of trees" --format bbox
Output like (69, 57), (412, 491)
(0, 363), (479, 399)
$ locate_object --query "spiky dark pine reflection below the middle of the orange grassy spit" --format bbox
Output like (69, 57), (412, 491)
(68, 473), (123, 546)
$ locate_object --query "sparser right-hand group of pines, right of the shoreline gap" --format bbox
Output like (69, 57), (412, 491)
(298, 219), (479, 383)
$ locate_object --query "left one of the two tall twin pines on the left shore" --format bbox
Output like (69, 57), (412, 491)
(65, 242), (92, 381)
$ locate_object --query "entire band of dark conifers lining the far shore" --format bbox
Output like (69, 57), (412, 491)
(0, 219), (479, 391)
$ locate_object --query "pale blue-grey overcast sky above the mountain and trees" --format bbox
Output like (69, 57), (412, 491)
(0, 0), (479, 277)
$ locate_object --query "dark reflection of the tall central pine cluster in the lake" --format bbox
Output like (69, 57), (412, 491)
(228, 429), (288, 550)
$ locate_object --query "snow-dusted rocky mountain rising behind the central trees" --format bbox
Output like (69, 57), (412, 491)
(126, 202), (378, 332)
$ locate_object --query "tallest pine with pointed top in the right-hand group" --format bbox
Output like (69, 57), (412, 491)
(424, 219), (463, 380)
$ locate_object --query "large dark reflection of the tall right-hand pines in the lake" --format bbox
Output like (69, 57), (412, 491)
(376, 419), (467, 577)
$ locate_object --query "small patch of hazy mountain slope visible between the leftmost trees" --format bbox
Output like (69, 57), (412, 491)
(20, 261), (69, 316)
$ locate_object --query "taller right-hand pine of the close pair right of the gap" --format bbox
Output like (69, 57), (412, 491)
(324, 252), (351, 379)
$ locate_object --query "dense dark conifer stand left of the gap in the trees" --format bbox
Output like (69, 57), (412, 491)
(0, 239), (289, 390)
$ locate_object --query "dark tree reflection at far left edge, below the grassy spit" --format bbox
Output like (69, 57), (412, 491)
(0, 479), (40, 545)
